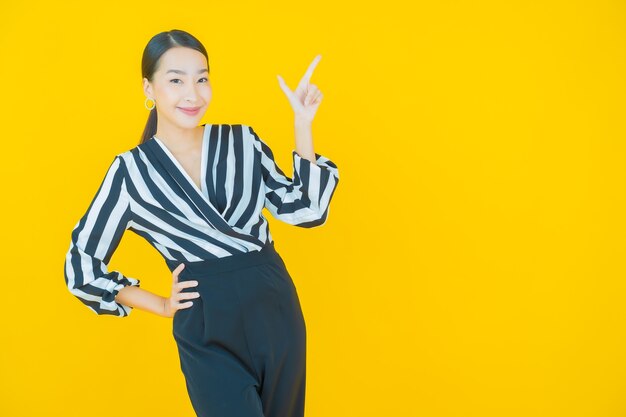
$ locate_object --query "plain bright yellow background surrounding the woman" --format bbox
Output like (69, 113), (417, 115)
(0, 0), (626, 417)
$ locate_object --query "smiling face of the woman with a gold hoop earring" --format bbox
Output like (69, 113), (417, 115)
(143, 47), (212, 128)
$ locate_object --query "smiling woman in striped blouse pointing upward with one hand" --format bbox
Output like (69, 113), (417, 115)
(65, 30), (339, 417)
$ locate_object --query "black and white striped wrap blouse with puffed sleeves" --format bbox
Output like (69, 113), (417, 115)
(64, 124), (339, 317)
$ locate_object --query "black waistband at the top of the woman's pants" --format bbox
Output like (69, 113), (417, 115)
(166, 241), (282, 280)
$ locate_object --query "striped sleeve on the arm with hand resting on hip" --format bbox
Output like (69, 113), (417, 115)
(64, 156), (139, 317)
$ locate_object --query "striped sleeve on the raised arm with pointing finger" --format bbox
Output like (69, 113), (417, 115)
(250, 127), (339, 228)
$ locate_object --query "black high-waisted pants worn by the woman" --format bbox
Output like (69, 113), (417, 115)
(167, 242), (306, 417)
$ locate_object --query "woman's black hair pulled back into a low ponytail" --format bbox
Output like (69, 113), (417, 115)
(139, 29), (211, 144)
